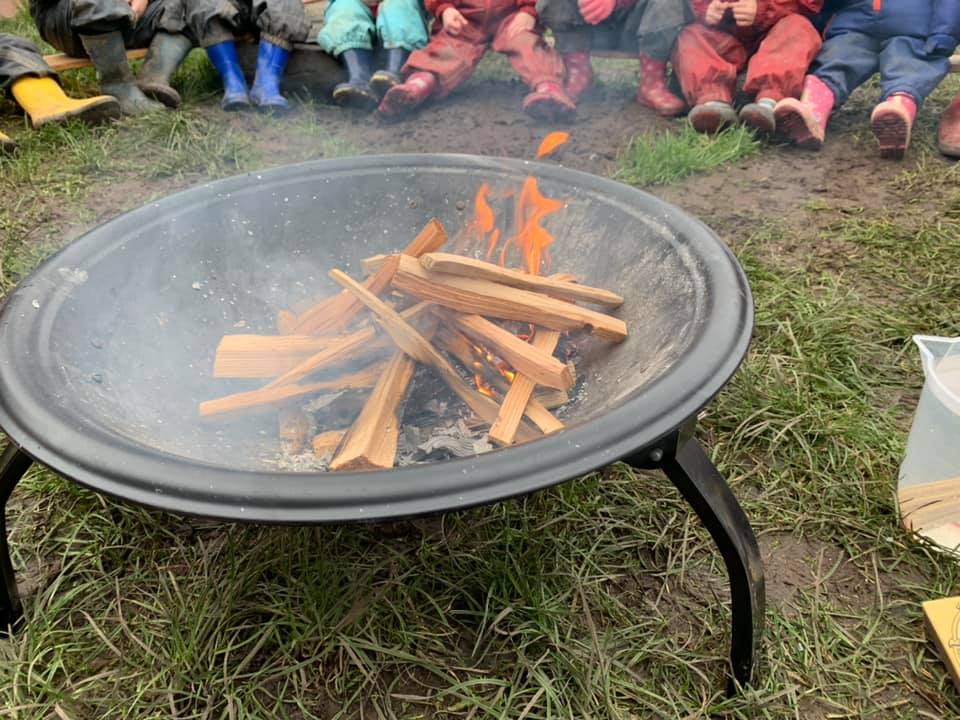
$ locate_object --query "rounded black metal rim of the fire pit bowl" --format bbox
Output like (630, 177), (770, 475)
(0, 154), (753, 524)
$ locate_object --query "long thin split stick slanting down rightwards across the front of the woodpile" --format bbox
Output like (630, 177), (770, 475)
(330, 268), (539, 442)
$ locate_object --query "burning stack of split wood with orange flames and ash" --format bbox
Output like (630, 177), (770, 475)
(200, 167), (627, 470)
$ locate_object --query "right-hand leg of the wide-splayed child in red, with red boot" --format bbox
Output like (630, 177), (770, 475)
(493, 12), (576, 120)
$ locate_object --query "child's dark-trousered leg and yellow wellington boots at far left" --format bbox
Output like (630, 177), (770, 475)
(0, 33), (120, 151)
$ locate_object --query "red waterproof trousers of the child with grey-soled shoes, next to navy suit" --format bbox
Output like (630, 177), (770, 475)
(673, 15), (822, 106)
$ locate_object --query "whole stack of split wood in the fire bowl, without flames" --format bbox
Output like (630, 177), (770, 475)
(200, 220), (627, 470)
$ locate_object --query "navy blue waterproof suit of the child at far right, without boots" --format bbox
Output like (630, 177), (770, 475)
(812, 0), (960, 106)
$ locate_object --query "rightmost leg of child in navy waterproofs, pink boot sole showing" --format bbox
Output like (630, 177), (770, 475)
(870, 35), (950, 160)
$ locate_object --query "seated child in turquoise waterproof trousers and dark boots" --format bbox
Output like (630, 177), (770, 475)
(317, 0), (427, 110)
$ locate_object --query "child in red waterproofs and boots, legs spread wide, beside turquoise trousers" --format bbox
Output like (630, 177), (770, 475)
(379, 0), (577, 121)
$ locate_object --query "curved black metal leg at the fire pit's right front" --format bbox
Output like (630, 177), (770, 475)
(628, 426), (765, 695)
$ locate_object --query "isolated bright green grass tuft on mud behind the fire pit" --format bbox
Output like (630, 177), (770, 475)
(616, 123), (760, 185)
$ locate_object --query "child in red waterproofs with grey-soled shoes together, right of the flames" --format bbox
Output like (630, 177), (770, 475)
(673, 0), (823, 134)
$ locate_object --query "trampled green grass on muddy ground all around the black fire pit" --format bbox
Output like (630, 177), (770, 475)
(0, 26), (960, 720)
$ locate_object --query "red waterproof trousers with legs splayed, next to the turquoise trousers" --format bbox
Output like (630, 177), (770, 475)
(403, 0), (564, 97)
